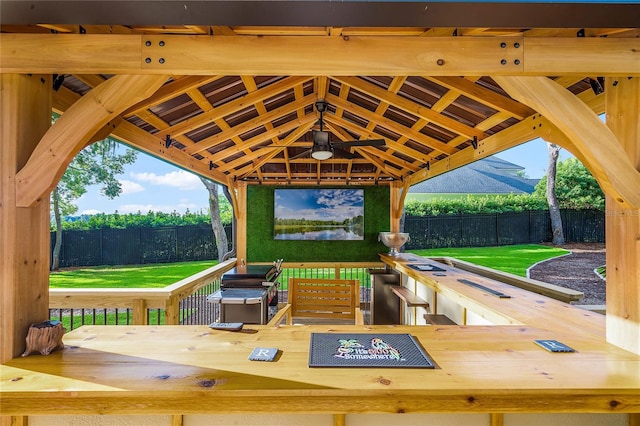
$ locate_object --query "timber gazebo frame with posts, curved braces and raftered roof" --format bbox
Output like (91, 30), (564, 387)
(0, 0), (640, 422)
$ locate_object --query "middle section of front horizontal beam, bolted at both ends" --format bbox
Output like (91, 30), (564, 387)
(141, 35), (523, 75)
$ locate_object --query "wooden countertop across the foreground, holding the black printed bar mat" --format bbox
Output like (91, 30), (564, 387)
(0, 325), (640, 415)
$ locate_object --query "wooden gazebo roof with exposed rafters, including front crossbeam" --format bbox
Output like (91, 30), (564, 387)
(1, 1), (640, 191)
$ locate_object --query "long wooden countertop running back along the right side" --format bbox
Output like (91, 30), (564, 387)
(380, 253), (606, 339)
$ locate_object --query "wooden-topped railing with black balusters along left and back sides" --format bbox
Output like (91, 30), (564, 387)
(49, 259), (384, 331)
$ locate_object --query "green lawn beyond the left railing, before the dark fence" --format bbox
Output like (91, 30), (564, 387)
(49, 260), (218, 288)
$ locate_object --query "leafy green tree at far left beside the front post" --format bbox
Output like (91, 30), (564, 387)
(51, 138), (137, 271)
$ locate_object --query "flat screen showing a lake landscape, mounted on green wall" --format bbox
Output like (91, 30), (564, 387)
(274, 189), (364, 240)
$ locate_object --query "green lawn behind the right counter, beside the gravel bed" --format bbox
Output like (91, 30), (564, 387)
(407, 244), (569, 277)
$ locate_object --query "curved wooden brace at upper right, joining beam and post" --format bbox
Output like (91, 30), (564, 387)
(495, 76), (640, 208)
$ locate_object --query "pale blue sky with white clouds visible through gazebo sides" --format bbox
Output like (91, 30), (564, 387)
(76, 139), (571, 214)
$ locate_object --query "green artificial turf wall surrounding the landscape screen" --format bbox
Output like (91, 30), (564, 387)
(247, 185), (390, 262)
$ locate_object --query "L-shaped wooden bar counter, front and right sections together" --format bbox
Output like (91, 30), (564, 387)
(0, 255), (640, 426)
